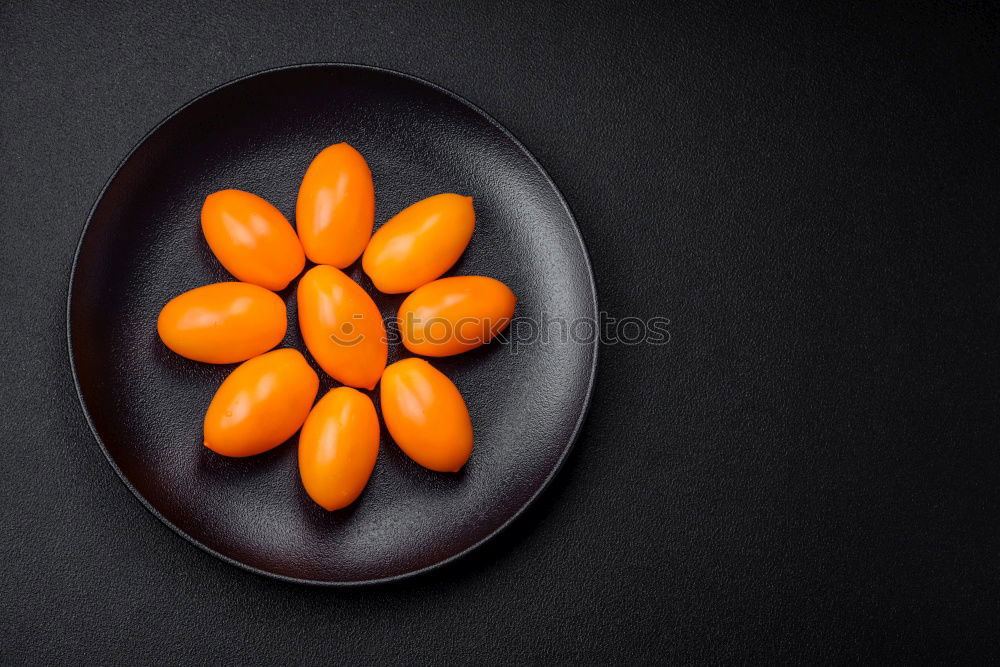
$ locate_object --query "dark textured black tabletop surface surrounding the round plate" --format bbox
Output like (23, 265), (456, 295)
(0, 0), (1000, 663)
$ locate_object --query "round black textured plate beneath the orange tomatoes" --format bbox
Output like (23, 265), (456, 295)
(68, 65), (597, 584)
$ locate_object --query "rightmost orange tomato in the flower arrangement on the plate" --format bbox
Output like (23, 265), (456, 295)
(399, 276), (517, 357)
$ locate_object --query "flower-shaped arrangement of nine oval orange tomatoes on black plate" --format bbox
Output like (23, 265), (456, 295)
(157, 143), (517, 510)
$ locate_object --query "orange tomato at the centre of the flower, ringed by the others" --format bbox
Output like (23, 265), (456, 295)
(298, 265), (389, 389)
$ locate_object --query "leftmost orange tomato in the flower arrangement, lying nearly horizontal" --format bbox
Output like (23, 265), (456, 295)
(156, 283), (288, 364)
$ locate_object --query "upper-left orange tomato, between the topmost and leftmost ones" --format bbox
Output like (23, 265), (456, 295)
(201, 190), (306, 292)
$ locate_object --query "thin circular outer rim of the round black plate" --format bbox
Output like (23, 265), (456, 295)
(66, 62), (600, 588)
